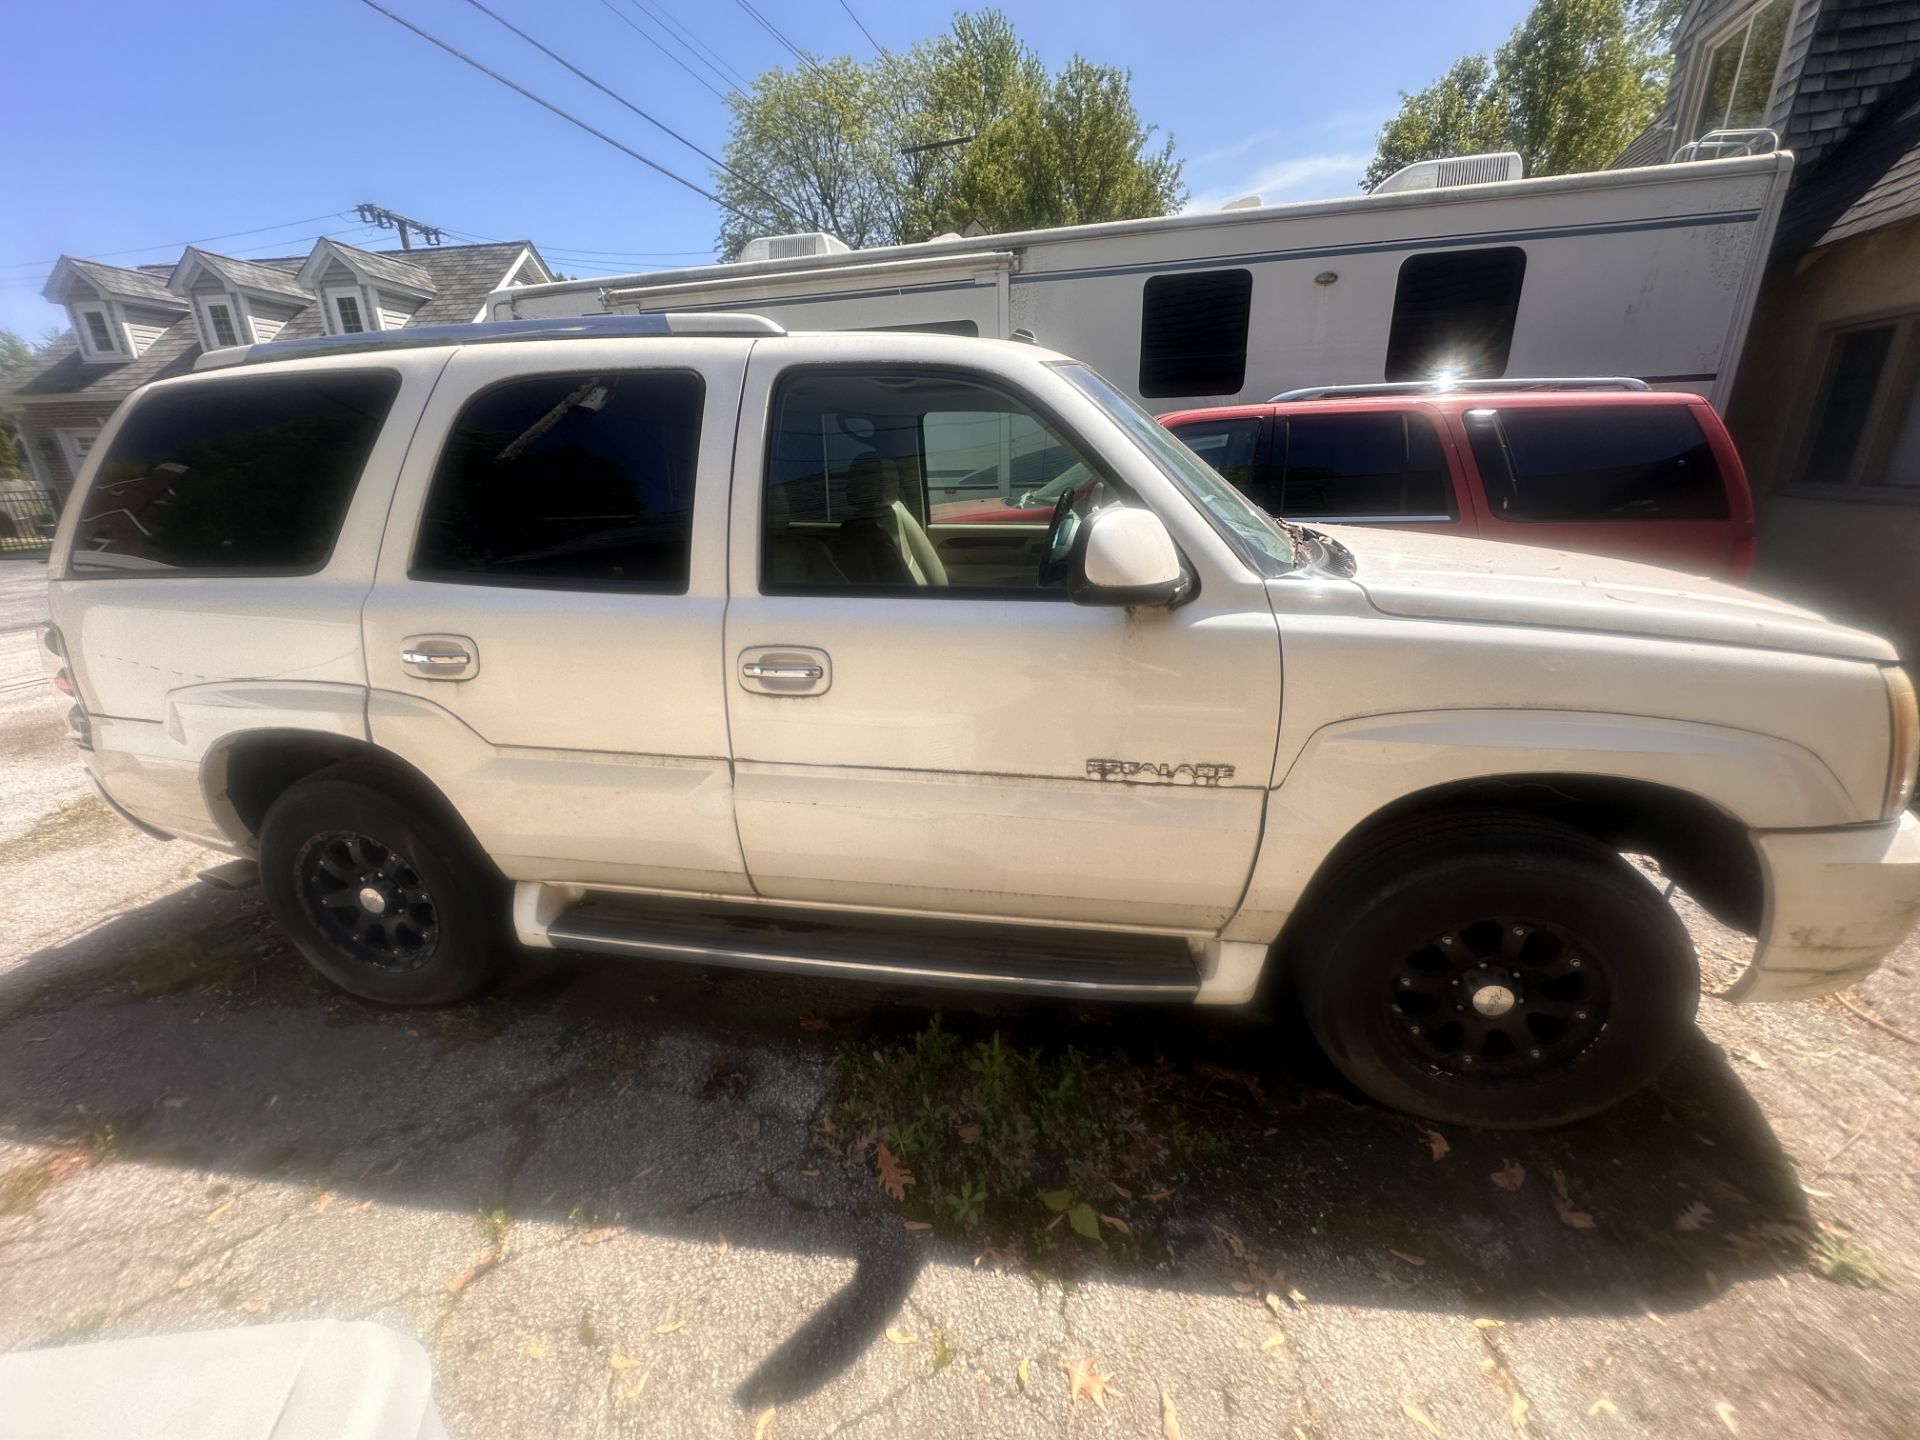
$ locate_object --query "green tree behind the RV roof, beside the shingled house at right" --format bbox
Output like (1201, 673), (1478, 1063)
(1365, 0), (1682, 188)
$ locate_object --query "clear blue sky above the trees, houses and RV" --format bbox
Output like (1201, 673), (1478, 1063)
(0, 0), (1526, 338)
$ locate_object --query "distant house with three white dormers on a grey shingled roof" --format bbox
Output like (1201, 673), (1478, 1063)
(10, 238), (553, 501)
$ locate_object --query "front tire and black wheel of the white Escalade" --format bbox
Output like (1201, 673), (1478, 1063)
(1288, 812), (1699, 1129)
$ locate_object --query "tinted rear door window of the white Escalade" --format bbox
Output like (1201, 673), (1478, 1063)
(411, 371), (707, 593)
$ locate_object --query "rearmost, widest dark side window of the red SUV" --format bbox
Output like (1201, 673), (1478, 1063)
(1467, 405), (1728, 520)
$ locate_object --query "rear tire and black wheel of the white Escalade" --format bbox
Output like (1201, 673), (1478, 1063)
(259, 762), (507, 1006)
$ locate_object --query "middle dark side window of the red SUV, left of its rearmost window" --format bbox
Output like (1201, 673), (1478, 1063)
(1279, 411), (1457, 520)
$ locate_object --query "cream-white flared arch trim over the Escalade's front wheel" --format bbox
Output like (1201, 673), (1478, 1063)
(1221, 710), (1851, 943)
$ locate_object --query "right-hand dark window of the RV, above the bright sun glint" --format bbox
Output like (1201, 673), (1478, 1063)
(1386, 246), (1526, 380)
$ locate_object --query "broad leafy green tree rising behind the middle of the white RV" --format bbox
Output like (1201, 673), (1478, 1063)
(714, 10), (1185, 259)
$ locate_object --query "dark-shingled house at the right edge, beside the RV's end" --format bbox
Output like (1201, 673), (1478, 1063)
(1617, 0), (1920, 664)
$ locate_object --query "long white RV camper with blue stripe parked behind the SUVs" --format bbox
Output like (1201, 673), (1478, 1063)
(488, 154), (1793, 411)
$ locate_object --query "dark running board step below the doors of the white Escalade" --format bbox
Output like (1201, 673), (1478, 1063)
(545, 895), (1200, 1002)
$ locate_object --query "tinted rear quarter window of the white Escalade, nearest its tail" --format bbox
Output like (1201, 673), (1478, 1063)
(69, 371), (399, 574)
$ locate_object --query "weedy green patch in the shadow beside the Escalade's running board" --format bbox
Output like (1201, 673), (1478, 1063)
(831, 1016), (1223, 1258)
